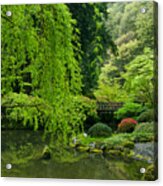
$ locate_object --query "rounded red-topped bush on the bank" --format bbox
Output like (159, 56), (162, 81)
(118, 118), (137, 133)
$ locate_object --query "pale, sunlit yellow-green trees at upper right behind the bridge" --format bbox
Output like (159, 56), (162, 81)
(94, 2), (157, 107)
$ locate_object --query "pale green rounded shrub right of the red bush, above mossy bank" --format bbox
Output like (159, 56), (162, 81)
(134, 122), (154, 133)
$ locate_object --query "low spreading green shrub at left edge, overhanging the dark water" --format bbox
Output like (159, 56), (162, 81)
(2, 93), (53, 130)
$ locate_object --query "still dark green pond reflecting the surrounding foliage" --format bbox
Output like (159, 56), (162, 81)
(1, 131), (149, 180)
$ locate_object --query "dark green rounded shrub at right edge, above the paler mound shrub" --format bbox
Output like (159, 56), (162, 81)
(138, 109), (154, 122)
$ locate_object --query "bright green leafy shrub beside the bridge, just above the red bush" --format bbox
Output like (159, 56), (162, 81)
(115, 103), (143, 119)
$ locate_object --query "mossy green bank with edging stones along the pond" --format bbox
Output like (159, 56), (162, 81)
(70, 132), (154, 159)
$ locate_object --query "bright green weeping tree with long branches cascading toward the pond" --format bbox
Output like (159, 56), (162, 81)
(1, 4), (84, 145)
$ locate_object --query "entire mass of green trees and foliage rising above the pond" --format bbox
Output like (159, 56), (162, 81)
(1, 2), (157, 145)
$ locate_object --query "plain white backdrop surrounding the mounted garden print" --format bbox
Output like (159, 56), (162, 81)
(0, 0), (163, 186)
